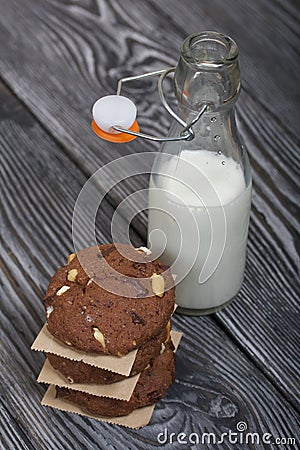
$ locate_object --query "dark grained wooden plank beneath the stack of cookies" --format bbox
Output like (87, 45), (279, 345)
(0, 86), (299, 450)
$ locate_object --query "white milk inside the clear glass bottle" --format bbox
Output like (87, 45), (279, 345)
(148, 150), (251, 310)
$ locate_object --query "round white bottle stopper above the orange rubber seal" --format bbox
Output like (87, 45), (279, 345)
(92, 95), (136, 133)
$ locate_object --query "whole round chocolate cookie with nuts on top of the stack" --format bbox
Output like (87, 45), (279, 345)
(44, 244), (174, 356)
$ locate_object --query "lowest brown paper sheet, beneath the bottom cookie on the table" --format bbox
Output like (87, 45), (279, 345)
(41, 330), (182, 428)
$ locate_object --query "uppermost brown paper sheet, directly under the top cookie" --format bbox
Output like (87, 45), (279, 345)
(31, 325), (137, 377)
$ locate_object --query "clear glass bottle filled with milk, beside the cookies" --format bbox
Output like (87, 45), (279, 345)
(148, 32), (251, 315)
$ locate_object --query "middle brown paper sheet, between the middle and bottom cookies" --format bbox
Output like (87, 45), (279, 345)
(37, 359), (140, 401)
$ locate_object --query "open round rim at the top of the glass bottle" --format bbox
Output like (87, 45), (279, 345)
(181, 31), (238, 70)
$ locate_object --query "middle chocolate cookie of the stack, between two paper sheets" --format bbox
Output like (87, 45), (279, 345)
(47, 322), (170, 384)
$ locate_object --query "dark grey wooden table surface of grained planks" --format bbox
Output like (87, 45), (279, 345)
(0, 0), (300, 450)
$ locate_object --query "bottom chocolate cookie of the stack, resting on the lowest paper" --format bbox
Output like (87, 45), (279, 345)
(56, 343), (175, 417)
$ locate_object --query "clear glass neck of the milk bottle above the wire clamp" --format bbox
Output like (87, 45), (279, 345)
(174, 32), (240, 122)
